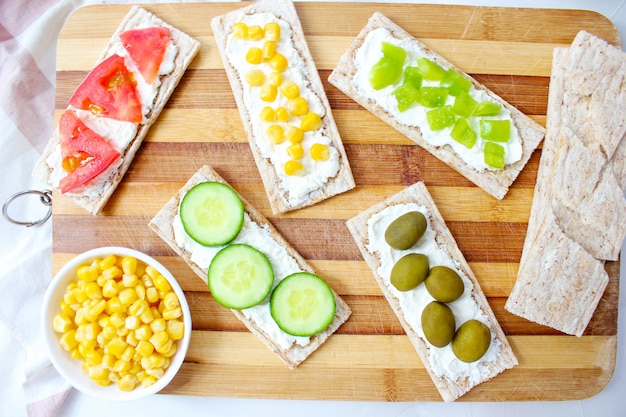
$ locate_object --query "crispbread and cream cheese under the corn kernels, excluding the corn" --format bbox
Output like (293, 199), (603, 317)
(211, 0), (355, 214)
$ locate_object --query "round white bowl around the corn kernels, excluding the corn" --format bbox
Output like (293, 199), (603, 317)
(41, 246), (191, 401)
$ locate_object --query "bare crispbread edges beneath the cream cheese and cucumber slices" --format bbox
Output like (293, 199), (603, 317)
(149, 165), (352, 369)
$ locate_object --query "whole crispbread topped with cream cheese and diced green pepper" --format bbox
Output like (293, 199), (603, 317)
(328, 13), (544, 199)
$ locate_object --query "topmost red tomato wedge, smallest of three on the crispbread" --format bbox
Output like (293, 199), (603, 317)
(120, 26), (170, 84)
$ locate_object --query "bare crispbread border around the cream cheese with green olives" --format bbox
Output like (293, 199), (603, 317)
(347, 182), (518, 401)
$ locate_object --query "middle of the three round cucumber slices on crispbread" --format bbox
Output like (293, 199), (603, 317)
(207, 244), (274, 310)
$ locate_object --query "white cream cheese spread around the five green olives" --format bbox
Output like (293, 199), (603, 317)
(367, 203), (501, 383)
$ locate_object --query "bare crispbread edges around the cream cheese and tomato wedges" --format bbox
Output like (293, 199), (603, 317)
(33, 6), (200, 215)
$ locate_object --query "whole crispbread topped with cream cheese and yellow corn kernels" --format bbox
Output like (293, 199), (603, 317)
(211, 0), (355, 214)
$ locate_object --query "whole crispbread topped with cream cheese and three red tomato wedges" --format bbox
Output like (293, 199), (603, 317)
(33, 6), (200, 215)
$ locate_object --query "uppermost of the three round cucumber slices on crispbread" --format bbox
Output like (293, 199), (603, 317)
(180, 182), (244, 246)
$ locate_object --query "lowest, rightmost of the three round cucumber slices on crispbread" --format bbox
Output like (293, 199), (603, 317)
(270, 272), (336, 336)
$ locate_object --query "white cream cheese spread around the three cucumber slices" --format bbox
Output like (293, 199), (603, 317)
(172, 205), (311, 359)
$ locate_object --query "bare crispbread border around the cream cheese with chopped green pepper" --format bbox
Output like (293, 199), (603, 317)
(328, 13), (544, 199)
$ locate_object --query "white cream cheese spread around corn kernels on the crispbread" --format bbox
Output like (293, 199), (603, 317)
(226, 13), (339, 205)
